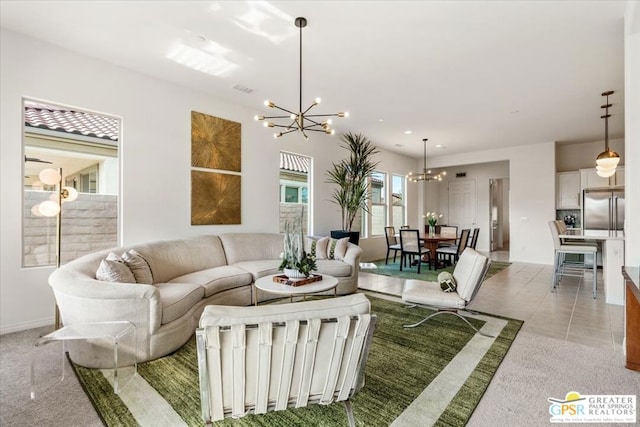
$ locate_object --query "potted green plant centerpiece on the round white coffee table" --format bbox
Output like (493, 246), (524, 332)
(278, 211), (318, 279)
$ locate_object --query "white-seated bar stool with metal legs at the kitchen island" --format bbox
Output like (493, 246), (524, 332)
(549, 221), (598, 299)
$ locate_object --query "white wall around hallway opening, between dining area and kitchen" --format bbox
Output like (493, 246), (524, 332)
(430, 142), (556, 264)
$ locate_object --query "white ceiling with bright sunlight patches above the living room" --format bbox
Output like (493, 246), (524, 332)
(0, 0), (626, 157)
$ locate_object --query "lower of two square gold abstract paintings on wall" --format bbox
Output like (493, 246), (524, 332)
(191, 170), (241, 225)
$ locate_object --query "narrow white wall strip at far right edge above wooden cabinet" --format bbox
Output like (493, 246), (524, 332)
(624, 1), (640, 267)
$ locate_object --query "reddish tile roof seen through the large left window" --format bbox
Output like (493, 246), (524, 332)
(24, 101), (120, 141)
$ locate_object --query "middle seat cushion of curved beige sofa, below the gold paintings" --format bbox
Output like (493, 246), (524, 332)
(169, 265), (253, 298)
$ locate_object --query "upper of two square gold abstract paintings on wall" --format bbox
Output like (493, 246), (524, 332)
(191, 111), (241, 172)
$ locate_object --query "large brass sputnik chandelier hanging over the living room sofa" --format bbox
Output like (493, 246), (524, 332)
(254, 17), (349, 139)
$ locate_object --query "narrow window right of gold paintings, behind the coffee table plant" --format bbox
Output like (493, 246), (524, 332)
(280, 151), (311, 234)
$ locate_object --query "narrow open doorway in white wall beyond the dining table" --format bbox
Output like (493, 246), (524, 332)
(489, 178), (509, 261)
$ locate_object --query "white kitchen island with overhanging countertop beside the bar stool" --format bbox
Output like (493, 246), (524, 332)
(560, 230), (624, 305)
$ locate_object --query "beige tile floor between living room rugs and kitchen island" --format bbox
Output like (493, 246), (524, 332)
(359, 252), (624, 353)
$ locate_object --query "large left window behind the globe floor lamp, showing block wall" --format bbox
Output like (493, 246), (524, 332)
(22, 99), (120, 267)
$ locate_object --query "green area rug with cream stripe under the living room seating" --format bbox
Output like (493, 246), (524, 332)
(74, 295), (522, 427)
